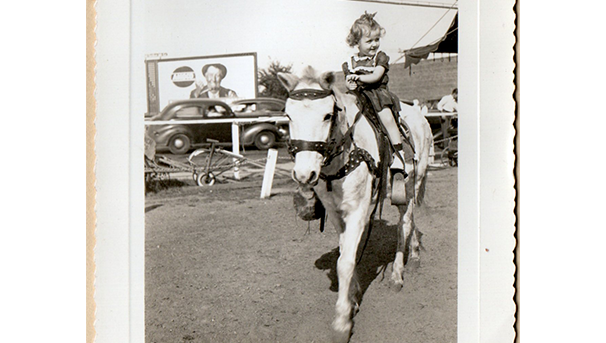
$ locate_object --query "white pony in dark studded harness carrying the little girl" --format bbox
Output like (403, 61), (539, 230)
(278, 67), (432, 342)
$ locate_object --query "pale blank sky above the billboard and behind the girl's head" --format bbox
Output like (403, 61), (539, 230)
(131, 0), (456, 113)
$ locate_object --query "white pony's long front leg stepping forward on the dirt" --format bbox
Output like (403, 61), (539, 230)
(333, 206), (366, 342)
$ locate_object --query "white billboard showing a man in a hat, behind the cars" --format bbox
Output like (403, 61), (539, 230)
(146, 53), (257, 113)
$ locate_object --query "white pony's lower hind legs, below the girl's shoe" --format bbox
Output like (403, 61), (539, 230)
(391, 200), (419, 288)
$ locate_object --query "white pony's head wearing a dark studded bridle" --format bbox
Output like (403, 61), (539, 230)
(278, 67), (338, 186)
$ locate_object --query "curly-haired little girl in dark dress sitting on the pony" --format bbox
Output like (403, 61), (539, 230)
(343, 12), (406, 203)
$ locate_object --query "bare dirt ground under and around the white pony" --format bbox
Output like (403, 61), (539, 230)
(145, 168), (457, 343)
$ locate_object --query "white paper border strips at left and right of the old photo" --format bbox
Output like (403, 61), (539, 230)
(95, 0), (515, 343)
